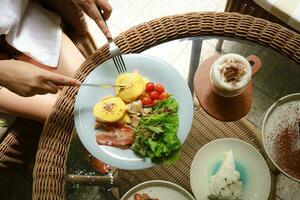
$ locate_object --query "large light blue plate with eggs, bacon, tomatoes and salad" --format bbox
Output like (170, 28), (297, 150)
(74, 54), (194, 170)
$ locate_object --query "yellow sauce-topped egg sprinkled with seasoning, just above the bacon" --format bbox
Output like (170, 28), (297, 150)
(93, 97), (126, 122)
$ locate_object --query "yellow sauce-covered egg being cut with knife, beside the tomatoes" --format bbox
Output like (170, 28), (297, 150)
(116, 73), (145, 102)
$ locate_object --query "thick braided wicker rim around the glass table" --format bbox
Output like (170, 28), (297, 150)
(33, 12), (300, 199)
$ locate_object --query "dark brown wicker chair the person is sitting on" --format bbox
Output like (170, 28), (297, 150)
(0, 0), (96, 172)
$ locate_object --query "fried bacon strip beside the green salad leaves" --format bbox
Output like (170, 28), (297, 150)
(96, 125), (134, 148)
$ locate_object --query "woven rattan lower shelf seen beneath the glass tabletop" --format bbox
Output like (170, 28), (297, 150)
(118, 106), (274, 198)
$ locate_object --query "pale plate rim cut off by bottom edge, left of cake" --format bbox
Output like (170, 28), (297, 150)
(121, 180), (195, 200)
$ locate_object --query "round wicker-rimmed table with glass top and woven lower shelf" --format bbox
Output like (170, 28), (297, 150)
(33, 13), (300, 200)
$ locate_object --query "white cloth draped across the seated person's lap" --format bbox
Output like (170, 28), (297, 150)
(0, 0), (62, 67)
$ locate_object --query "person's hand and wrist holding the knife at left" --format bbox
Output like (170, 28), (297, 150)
(0, 60), (80, 97)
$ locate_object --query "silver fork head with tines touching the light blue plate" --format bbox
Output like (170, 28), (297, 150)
(109, 40), (127, 74)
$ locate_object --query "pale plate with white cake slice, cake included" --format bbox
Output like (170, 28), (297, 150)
(190, 138), (271, 200)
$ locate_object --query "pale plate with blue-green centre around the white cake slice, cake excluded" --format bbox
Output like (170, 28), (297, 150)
(190, 138), (271, 200)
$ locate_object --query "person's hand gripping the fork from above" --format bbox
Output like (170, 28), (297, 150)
(73, 0), (112, 39)
